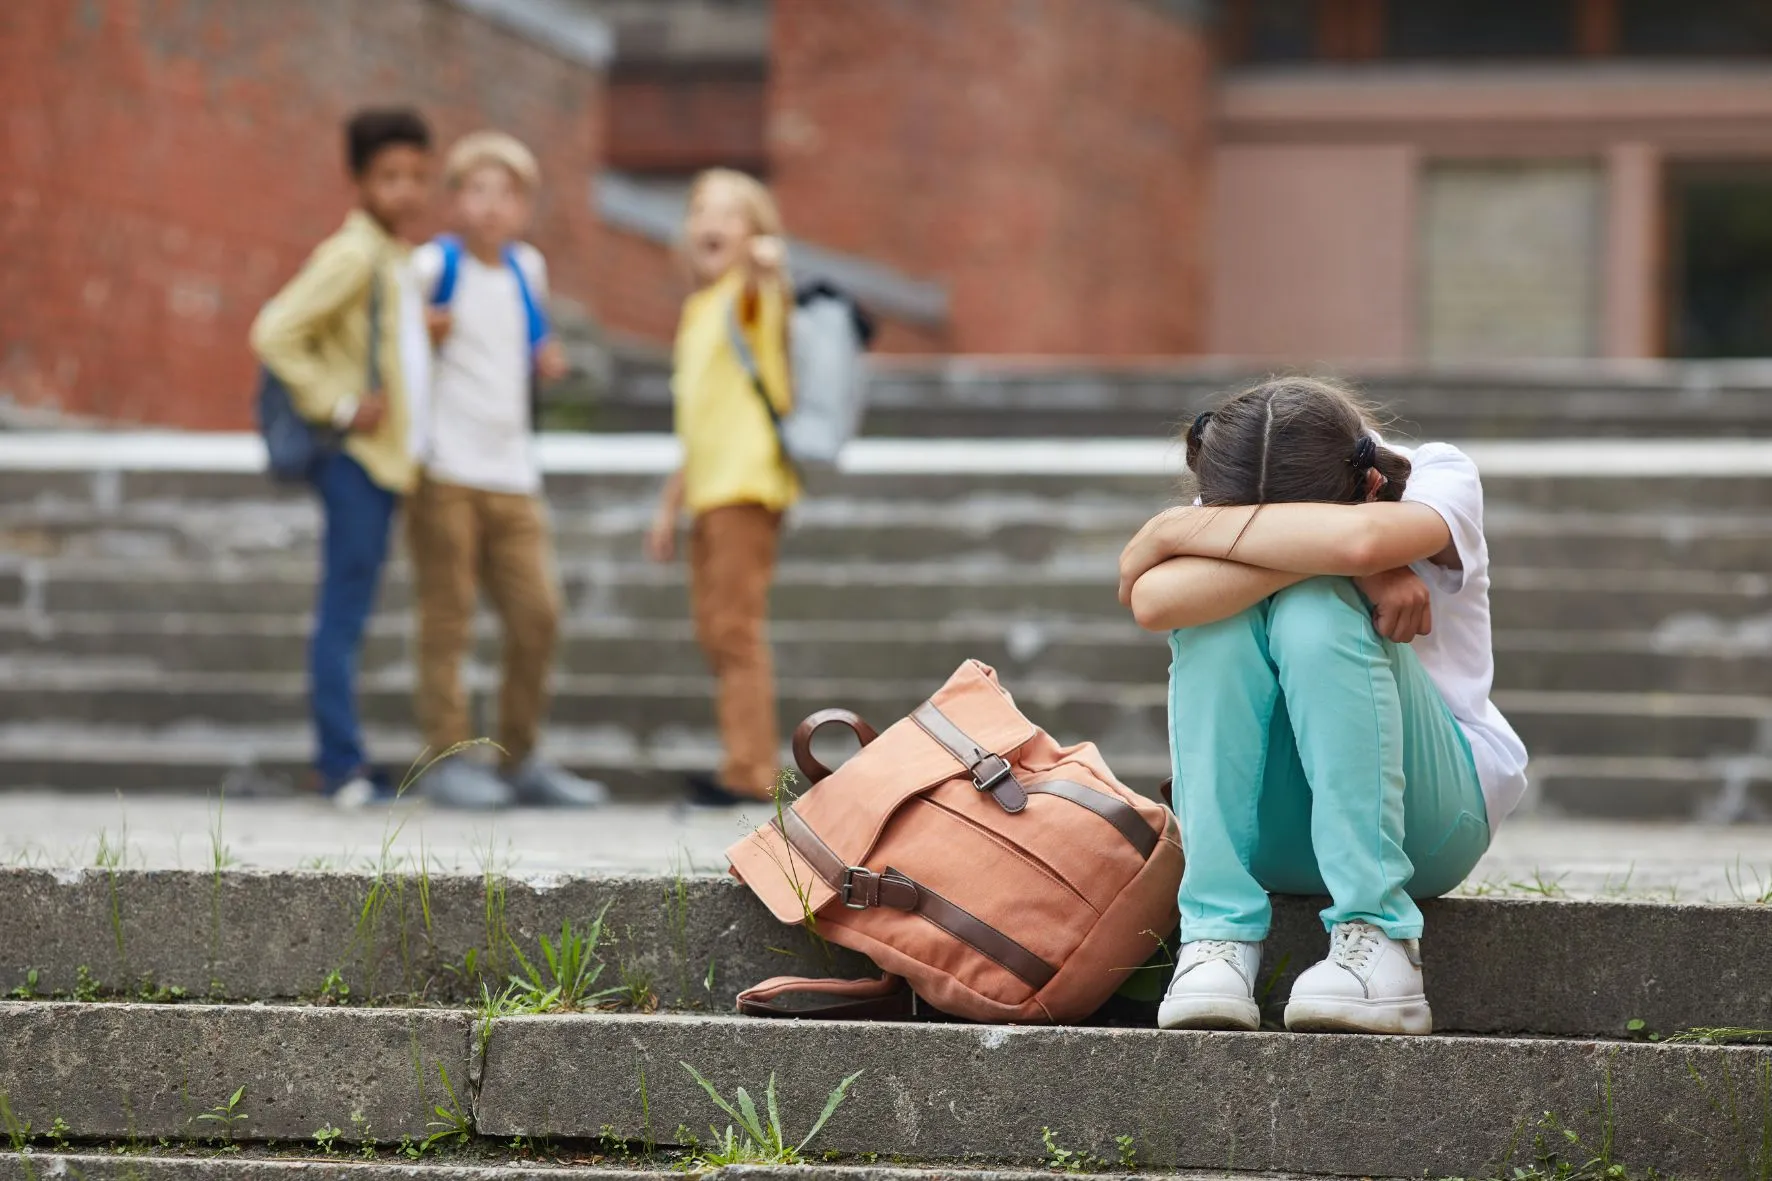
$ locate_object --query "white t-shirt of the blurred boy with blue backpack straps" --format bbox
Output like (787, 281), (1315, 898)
(413, 243), (548, 493)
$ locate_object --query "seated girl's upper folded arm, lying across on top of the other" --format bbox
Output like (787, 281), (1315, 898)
(1120, 502), (1458, 599)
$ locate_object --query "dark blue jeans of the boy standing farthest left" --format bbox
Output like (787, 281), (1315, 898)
(308, 452), (400, 791)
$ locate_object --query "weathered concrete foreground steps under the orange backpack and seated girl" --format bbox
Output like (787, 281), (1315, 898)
(0, 865), (1772, 1181)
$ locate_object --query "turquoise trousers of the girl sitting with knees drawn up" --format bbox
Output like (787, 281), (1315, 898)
(1170, 578), (1488, 942)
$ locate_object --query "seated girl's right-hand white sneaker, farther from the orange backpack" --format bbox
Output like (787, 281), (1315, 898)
(1286, 922), (1434, 1034)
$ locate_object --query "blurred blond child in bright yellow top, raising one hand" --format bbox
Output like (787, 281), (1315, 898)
(647, 168), (799, 807)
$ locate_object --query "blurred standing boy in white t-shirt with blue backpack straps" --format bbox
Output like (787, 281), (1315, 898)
(408, 131), (608, 809)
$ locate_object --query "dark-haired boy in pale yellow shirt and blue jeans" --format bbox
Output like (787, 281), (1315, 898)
(252, 110), (431, 807)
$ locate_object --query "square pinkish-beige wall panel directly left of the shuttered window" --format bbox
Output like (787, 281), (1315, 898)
(1207, 145), (1416, 364)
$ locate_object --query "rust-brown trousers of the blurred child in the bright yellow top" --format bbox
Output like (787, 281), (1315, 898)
(689, 504), (781, 798)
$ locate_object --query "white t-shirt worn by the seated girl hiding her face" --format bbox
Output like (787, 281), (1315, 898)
(1393, 443), (1526, 830)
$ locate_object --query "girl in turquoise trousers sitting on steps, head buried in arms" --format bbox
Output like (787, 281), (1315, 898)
(1120, 378), (1526, 1034)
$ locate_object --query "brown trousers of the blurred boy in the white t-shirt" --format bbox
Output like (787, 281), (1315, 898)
(406, 477), (560, 768)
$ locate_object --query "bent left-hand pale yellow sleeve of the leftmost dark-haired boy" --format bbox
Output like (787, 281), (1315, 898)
(252, 239), (376, 422)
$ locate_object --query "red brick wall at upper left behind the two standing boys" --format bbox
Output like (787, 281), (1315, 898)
(0, 0), (601, 427)
